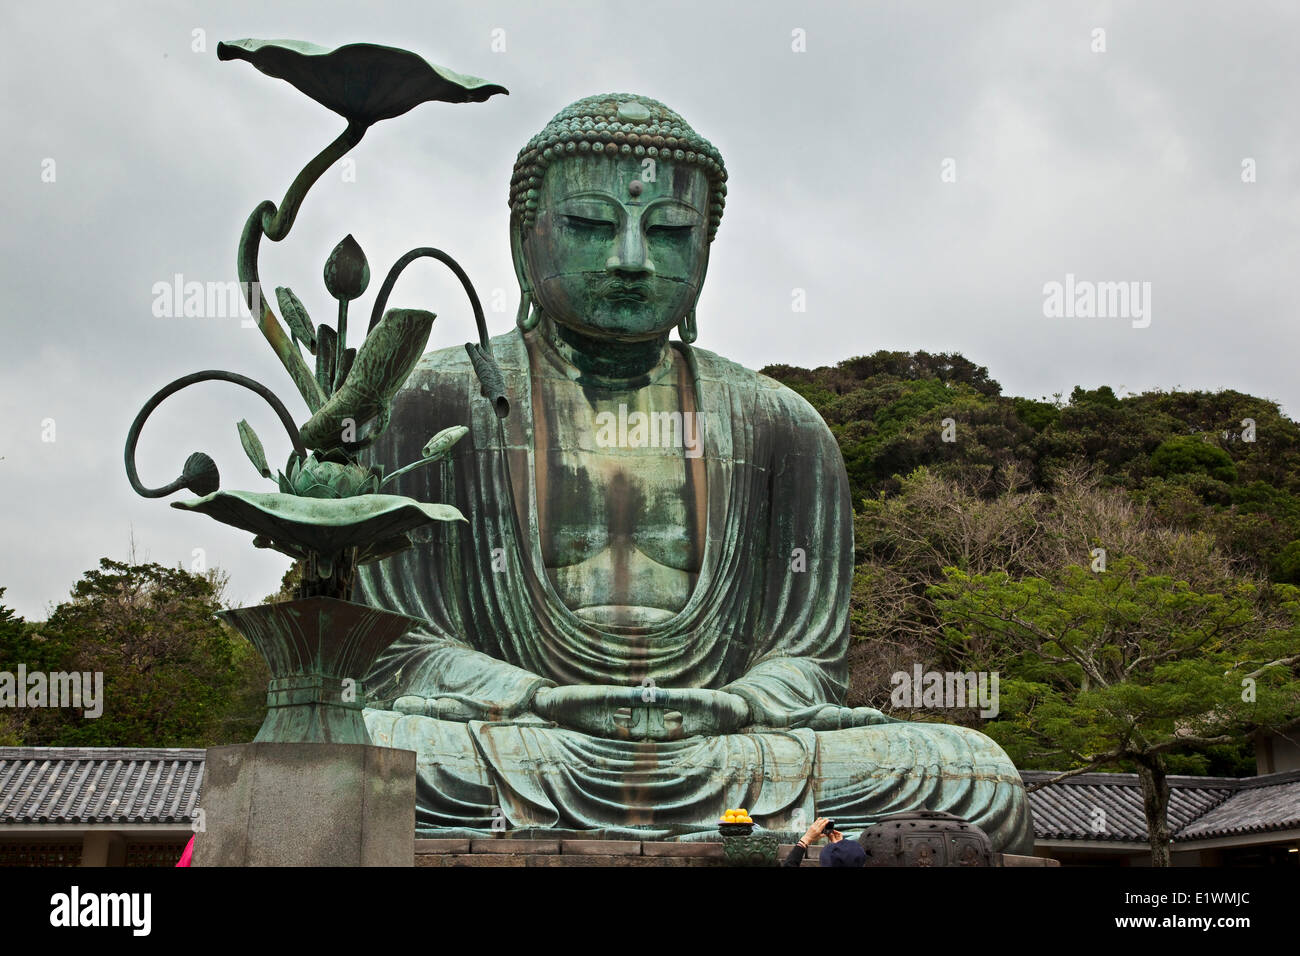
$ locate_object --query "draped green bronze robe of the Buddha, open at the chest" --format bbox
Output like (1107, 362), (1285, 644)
(359, 330), (1032, 852)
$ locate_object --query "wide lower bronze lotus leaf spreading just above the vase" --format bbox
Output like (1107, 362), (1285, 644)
(172, 492), (465, 555)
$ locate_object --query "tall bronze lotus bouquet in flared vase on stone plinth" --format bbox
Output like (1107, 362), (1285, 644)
(126, 40), (510, 743)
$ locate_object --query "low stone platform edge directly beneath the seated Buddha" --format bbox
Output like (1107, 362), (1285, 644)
(415, 836), (1060, 866)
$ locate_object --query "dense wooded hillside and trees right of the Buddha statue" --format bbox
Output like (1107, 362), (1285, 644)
(764, 352), (1300, 864)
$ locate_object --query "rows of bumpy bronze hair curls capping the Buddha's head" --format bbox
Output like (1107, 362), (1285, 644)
(510, 92), (727, 242)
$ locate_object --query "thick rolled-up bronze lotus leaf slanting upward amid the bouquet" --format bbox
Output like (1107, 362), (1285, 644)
(300, 308), (436, 449)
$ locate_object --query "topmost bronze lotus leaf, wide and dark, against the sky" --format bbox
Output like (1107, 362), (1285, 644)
(217, 39), (508, 126)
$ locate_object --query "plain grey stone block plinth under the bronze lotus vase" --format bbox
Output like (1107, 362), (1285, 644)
(192, 743), (415, 866)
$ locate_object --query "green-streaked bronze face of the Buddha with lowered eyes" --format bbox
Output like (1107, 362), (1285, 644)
(521, 155), (710, 341)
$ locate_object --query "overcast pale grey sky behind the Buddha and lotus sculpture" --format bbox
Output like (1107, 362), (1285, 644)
(0, 0), (1300, 619)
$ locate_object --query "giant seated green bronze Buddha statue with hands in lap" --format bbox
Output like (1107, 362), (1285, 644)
(359, 94), (1032, 852)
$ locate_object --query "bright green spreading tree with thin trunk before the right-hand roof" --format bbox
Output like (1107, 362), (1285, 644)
(932, 557), (1300, 866)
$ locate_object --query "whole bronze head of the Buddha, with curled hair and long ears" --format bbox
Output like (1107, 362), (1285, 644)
(510, 94), (727, 342)
